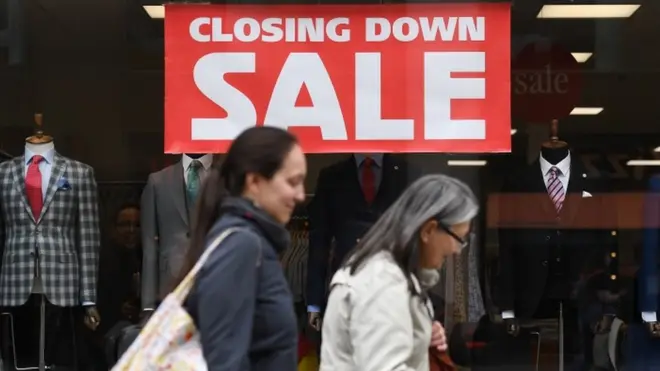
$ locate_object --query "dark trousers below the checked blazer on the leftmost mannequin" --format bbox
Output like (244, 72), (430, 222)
(0, 294), (88, 371)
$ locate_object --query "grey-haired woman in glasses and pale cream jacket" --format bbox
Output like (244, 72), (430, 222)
(320, 175), (479, 371)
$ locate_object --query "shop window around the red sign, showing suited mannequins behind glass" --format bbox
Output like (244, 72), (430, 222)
(0, 0), (660, 370)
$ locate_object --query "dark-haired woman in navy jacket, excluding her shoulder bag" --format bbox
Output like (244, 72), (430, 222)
(181, 127), (307, 371)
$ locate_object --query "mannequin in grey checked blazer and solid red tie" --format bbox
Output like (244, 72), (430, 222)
(0, 114), (100, 370)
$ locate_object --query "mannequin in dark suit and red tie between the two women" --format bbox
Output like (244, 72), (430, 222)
(307, 154), (420, 330)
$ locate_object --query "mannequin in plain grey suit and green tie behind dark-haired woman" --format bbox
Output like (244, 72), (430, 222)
(141, 154), (213, 314)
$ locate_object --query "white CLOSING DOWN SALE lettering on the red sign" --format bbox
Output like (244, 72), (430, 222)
(189, 17), (486, 141)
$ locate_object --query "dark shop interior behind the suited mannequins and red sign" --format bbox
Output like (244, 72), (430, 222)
(0, 0), (660, 370)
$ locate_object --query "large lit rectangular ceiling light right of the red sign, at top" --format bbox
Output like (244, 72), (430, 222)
(536, 4), (641, 18)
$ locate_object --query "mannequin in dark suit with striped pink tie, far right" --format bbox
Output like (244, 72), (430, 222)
(495, 120), (613, 369)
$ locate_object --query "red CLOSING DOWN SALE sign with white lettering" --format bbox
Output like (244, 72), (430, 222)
(165, 3), (511, 153)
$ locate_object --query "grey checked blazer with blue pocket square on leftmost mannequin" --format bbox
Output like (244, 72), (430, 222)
(0, 153), (100, 307)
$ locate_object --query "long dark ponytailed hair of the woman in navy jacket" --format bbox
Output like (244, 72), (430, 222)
(174, 126), (298, 287)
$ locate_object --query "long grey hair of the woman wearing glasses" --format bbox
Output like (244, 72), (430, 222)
(344, 174), (479, 288)
